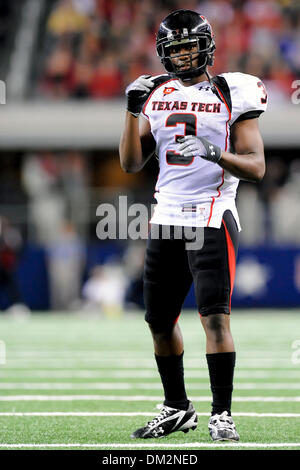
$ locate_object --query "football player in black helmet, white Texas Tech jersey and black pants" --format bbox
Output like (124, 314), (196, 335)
(119, 10), (267, 441)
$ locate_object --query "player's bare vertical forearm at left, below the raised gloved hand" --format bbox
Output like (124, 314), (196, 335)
(119, 111), (144, 173)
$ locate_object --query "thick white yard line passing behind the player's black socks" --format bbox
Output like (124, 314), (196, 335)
(0, 382), (300, 390)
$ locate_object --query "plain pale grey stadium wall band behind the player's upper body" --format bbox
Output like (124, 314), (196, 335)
(0, 100), (300, 150)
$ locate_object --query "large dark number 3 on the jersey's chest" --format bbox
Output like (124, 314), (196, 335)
(166, 113), (197, 166)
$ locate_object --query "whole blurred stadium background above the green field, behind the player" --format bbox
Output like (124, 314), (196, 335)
(0, 0), (300, 312)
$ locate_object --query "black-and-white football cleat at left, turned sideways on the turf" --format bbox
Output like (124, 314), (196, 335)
(130, 402), (198, 439)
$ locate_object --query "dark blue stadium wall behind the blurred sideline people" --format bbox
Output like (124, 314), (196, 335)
(0, 242), (300, 310)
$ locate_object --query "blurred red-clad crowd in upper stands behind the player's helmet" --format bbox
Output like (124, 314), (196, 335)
(37, 0), (300, 99)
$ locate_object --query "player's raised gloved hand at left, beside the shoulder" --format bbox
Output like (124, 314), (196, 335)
(125, 75), (155, 117)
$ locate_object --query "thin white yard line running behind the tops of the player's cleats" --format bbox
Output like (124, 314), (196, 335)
(0, 411), (300, 418)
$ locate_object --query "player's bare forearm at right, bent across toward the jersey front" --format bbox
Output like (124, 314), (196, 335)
(218, 152), (266, 183)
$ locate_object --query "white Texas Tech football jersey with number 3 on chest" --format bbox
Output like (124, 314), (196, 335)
(142, 73), (267, 229)
